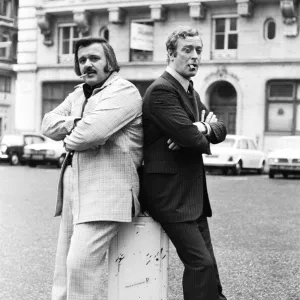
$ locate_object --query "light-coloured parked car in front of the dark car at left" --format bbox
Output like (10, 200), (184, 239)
(23, 139), (66, 168)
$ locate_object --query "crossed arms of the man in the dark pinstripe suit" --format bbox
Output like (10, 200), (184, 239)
(148, 85), (227, 154)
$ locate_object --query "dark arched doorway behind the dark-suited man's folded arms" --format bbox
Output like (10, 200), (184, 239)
(209, 81), (237, 134)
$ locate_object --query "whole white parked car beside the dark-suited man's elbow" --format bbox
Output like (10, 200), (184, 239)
(203, 134), (266, 175)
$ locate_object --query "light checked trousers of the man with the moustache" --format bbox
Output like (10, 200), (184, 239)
(52, 166), (122, 300)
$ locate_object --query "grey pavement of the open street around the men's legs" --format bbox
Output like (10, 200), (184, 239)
(0, 164), (300, 300)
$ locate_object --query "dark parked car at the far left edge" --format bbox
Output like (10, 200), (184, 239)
(0, 133), (45, 165)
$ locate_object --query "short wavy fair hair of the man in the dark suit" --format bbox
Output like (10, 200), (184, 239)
(166, 26), (200, 63)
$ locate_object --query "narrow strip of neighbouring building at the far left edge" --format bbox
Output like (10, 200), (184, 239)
(0, 0), (18, 136)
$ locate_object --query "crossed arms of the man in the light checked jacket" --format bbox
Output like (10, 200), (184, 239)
(42, 84), (141, 151)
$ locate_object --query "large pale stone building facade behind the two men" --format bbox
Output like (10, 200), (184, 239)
(15, 0), (300, 151)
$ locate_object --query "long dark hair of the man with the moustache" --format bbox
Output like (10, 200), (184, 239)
(74, 37), (120, 76)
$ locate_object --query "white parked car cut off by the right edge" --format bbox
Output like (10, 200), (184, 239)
(268, 136), (300, 178)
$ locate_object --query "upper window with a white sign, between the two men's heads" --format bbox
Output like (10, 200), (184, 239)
(130, 21), (154, 61)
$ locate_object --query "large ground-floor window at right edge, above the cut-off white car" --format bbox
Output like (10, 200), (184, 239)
(266, 81), (300, 135)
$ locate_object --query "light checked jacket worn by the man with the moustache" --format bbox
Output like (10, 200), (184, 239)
(42, 72), (143, 224)
